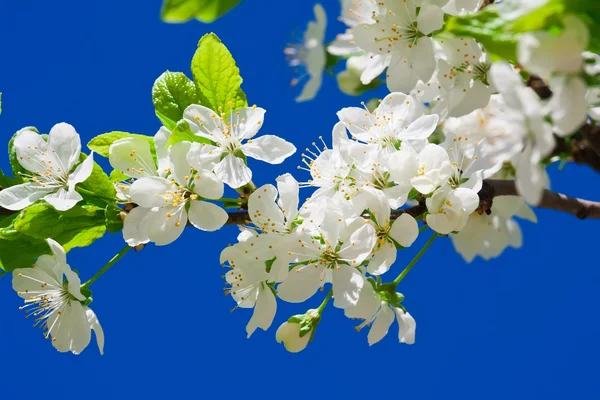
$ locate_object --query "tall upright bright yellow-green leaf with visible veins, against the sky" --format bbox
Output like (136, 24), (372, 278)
(192, 33), (248, 113)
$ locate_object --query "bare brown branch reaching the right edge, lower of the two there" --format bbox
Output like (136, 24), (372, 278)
(480, 179), (600, 219)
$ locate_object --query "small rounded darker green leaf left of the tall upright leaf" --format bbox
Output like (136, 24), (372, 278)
(152, 71), (200, 130)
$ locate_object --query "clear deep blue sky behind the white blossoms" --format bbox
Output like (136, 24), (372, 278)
(0, 0), (600, 400)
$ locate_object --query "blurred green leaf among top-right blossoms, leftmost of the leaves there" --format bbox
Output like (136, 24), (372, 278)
(444, 8), (517, 61)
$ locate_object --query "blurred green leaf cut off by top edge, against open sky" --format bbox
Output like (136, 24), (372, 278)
(161, 0), (241, 23)
